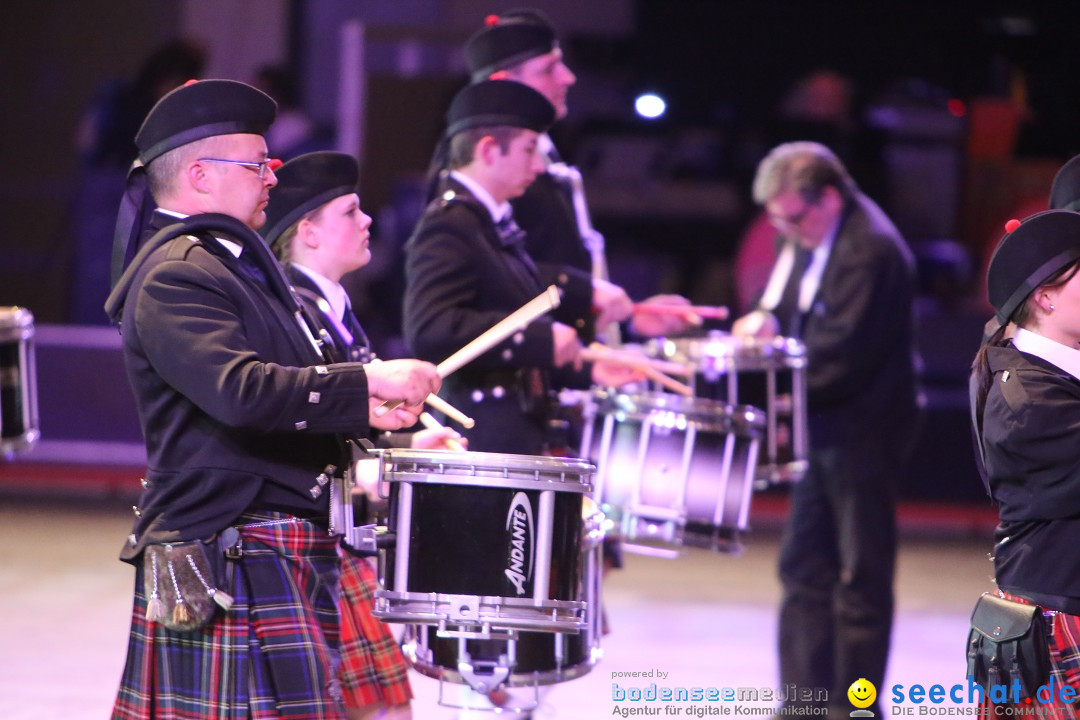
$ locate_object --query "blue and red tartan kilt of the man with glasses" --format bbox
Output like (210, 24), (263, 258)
(112, 514), (345, 720)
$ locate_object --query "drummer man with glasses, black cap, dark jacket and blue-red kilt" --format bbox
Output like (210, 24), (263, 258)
(106, 80), (438, 719)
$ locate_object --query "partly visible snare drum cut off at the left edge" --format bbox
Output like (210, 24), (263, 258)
(0, 308), (41, 456)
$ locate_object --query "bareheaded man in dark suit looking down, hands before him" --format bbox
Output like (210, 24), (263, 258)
(732, 142), (918, 715)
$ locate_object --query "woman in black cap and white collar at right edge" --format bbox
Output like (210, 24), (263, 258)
(972, 210), (1080, 717)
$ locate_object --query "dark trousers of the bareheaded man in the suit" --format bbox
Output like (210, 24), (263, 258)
(779, 441), (907, 717)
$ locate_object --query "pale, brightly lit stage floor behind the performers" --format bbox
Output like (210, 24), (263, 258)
(0, 497), (991, 720)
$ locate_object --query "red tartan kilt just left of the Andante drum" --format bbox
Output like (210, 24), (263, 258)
(338, 548), (413, 707)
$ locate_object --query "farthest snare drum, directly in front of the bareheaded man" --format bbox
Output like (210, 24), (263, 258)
(647, 331), (809, 488)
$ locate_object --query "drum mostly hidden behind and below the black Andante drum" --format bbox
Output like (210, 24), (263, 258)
(402, 505), (605, 710)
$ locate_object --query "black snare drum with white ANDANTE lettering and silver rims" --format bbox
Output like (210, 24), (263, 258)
(373, 448), (595, 633)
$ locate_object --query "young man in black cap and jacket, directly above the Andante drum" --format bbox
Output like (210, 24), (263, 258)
(405, 81), (633, 454)
